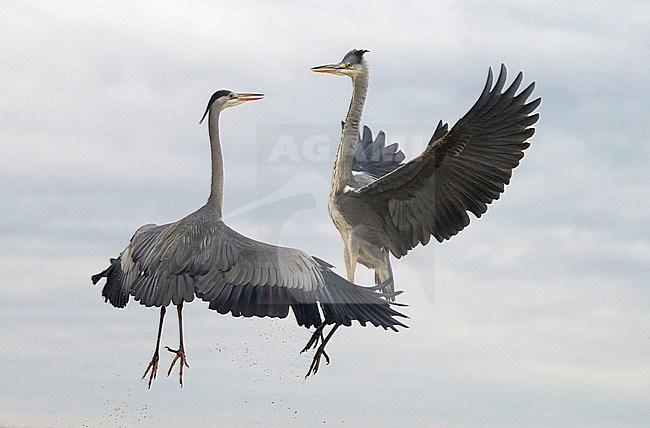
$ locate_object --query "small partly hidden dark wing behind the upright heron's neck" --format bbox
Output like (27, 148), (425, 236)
(352, 126), (406, 178)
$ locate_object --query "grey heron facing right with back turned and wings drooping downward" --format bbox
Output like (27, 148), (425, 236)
(92, 90), (406, 388)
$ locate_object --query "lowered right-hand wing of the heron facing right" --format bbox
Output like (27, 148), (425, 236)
(192, 229), (404, 329)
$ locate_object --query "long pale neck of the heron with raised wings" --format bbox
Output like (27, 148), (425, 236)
(332, 67), (368, 193)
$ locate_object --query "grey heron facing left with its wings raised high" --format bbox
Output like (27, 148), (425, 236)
(312, 49), (541, 362)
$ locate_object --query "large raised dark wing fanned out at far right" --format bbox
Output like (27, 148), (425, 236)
(347, 65), (541, 257)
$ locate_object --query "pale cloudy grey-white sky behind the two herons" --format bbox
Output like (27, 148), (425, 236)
(0, 0), (650, 427)
